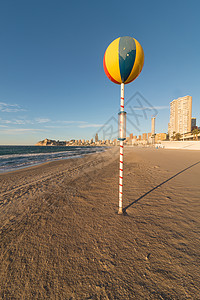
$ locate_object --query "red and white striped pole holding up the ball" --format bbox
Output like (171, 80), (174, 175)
(118, 83), (126, 214)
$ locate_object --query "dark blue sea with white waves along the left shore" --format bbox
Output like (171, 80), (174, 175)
(0, 146), (105, 173)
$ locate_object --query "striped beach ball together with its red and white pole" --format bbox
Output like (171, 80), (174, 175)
(103, 36), (144, 214)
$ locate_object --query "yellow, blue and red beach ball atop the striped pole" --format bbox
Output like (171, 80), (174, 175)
(103, 36), (144, 84)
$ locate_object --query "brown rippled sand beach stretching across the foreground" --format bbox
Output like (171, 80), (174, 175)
(0, 147), (200, 300)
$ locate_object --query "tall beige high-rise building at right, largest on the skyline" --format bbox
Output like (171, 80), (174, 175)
(168, 96), (192, 137)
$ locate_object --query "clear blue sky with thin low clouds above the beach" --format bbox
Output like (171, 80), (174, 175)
(0, 0), (200, 145)
